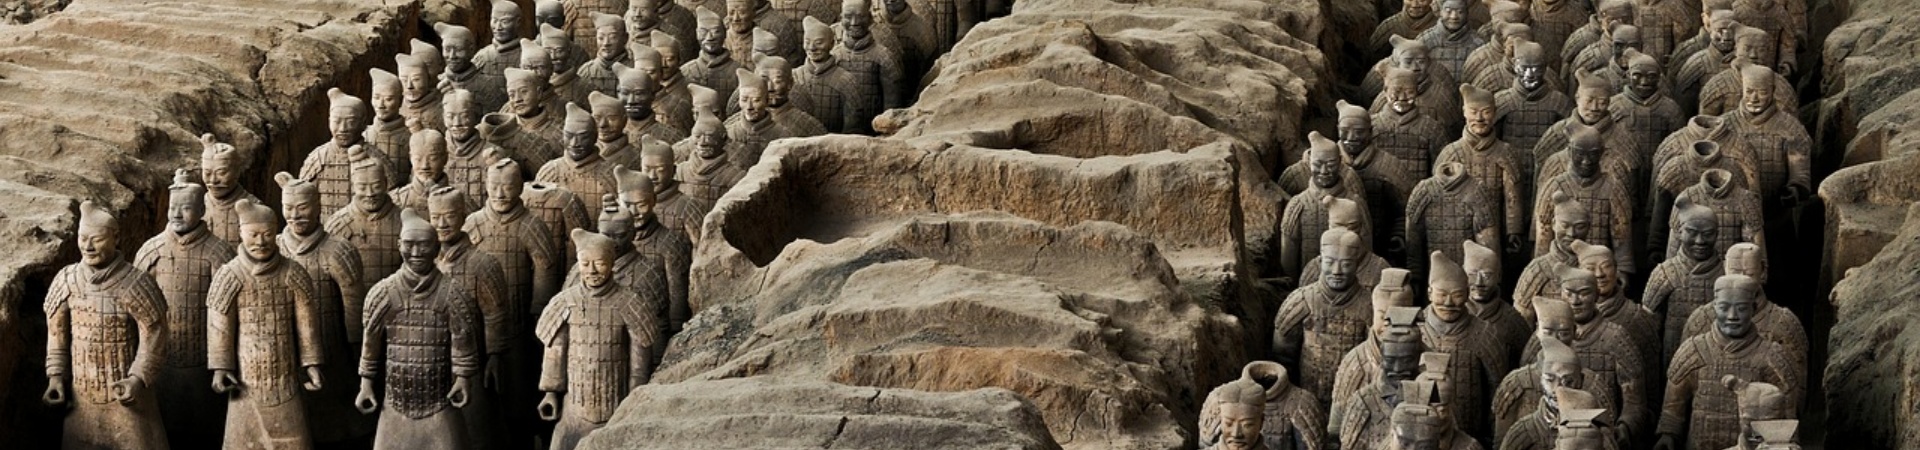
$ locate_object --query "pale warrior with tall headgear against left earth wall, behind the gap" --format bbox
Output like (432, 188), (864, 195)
(299, 88), (386, 217)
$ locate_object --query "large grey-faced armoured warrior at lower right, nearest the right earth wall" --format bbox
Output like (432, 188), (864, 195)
(1653, 275), (1805, 450)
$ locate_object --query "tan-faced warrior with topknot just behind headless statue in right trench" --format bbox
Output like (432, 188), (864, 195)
(1443, 85), (1534, 254)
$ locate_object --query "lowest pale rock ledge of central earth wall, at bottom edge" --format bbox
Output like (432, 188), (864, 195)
(580, 377), (1060, 450)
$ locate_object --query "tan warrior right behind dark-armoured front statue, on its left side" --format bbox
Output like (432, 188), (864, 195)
(326, 146), (399, 279)
